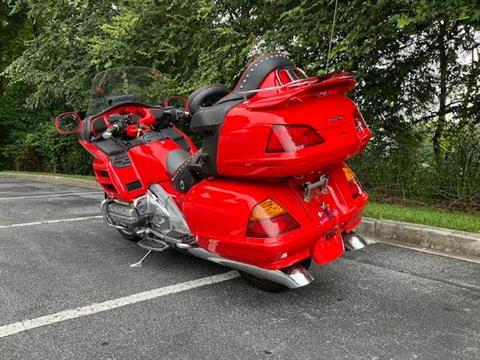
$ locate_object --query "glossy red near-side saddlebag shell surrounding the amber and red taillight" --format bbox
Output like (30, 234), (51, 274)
(183, 179), (326, 269)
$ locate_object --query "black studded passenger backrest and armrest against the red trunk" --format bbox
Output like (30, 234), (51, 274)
(188, 52), (292, 176)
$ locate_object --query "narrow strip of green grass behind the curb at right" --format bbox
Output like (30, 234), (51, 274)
(364, 202), (480, 233)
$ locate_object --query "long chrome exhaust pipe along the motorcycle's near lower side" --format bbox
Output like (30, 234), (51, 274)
(154, 232), (314, 289)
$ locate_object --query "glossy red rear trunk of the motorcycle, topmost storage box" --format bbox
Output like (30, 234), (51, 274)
(217, 73), (371, 178)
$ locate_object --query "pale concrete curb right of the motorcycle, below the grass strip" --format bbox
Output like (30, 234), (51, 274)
(356, 218), (480, 259)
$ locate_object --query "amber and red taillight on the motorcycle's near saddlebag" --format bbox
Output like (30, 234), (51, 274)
(247, 199), (300, 238)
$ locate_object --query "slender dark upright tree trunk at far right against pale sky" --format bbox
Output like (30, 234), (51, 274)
(432, 21), (448, 164)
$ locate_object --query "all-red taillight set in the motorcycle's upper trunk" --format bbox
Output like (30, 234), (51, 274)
(265, 125), (324, 153)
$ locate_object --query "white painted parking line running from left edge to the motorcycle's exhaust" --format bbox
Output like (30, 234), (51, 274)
(0, 271), (239, 338)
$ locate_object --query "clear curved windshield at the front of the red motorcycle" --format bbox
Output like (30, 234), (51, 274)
(87, 66), (168, 116)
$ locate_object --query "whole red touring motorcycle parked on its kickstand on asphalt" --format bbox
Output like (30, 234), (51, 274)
(55, 53), (371, 291)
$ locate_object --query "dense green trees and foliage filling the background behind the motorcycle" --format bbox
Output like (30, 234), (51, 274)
(0, 0), (480, 207)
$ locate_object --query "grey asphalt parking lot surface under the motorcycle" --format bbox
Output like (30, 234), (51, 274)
(0, 176), (480, 360)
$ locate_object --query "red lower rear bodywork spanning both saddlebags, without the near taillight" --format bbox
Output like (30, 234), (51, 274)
(183, 163), (368, 269)
